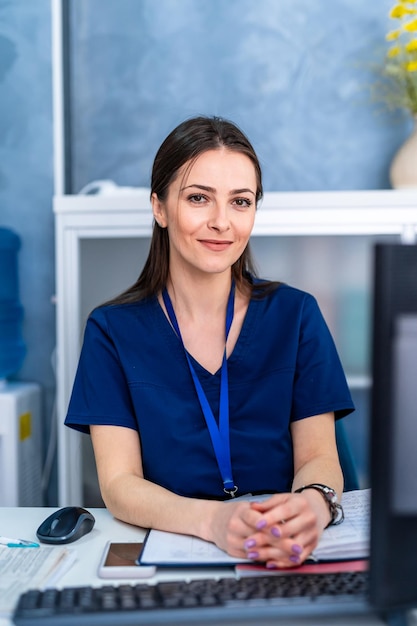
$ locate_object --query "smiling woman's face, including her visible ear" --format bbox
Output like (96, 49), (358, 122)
(152, 148), (257, 274)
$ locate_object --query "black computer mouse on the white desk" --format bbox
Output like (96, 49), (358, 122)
(36, 506), (96, 544)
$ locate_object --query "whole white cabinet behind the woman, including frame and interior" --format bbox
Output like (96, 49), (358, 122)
(54, 189), (417, 506)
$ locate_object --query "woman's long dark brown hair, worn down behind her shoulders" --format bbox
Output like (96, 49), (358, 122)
(105, 116), (276, 304)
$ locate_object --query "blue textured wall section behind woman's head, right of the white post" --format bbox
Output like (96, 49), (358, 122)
(71, 0), (407, 191)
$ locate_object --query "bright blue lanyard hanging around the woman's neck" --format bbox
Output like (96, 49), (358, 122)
(162, 282), (238, 498)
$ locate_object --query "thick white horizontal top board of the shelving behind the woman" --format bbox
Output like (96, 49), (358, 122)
(54, 188), (417, 243)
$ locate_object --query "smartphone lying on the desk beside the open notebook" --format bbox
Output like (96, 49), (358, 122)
(98, 541), (156, 578)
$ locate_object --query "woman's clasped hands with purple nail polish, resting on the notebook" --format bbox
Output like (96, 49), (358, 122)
(216, 493), (325, 569)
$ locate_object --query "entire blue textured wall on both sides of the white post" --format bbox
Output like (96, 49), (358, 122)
(0, 0), (409, 504)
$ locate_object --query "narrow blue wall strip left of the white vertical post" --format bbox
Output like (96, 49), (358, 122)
(0, 0), (55, 498)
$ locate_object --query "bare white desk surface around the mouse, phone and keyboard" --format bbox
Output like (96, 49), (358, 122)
(0, 507), (383, 626)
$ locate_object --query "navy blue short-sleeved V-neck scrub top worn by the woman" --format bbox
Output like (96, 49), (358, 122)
(65, 285), (354, 498)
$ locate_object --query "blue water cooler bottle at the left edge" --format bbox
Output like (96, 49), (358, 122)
(0, 227), (26, 384)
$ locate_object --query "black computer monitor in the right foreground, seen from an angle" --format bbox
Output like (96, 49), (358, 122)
(370, 244), (417, 611)
